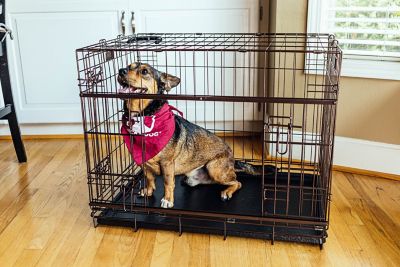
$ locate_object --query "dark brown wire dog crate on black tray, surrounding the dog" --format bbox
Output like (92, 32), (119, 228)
(76, 33), (342, 247)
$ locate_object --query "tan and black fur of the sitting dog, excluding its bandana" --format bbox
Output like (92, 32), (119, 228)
(118, 63), (241, 208)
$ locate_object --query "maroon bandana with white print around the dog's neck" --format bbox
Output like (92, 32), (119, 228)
(121, 103), (182, 165)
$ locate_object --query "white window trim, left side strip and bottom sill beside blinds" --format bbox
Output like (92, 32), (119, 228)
(307, 0), (400, 80)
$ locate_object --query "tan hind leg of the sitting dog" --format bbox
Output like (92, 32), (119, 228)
(206, 157), (242, 201)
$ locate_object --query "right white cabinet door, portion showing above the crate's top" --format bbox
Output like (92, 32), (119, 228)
(132, 0), (259, 33)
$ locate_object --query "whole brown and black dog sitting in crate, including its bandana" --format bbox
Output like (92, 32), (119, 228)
(117, 62), (242, 208)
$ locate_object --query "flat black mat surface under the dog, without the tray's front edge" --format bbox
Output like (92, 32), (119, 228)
(108, 172), (325, 219)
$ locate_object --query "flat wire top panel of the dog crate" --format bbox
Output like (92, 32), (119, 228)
(77, 33), (341, 54)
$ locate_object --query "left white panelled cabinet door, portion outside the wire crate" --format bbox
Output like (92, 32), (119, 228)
(6, 0), (129, 123)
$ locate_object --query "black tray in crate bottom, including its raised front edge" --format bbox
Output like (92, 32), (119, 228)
(97, 172), (325, 244)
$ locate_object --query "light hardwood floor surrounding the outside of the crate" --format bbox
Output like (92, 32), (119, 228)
(0, 139), (400, 267)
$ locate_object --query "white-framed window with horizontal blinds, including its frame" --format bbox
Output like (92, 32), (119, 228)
(307, 0), (400, 80)
